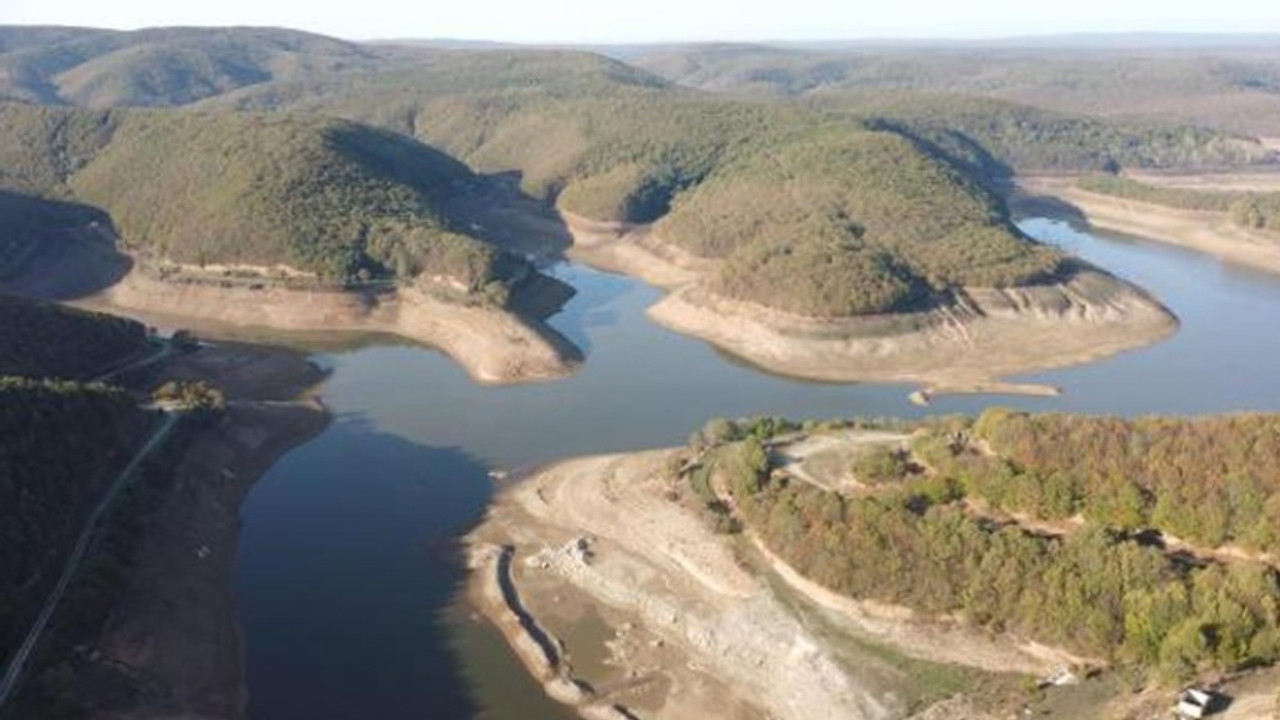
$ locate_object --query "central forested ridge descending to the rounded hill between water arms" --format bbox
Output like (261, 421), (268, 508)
(207, 53), (1059, 316)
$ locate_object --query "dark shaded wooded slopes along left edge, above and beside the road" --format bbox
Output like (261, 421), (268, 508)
(0, 295), (154, 676)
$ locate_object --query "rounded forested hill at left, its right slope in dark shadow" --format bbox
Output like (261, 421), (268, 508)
(0, 104), (527, 296)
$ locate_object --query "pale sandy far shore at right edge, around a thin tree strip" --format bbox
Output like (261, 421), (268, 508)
(1015, 174), (1280, 273)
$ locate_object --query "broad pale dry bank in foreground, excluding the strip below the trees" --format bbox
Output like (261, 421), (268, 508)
(468, 452), (892, 720)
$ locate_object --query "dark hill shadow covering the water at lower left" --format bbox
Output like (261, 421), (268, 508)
(237, 415), (492, 720)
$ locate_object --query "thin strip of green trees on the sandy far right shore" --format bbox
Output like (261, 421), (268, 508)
(1076, 174), (1280, 233)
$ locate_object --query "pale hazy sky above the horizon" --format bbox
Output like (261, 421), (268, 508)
(0, 0), (1280, 42)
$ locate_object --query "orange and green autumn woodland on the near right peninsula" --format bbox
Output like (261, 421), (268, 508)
(691, 411), (1280, 680)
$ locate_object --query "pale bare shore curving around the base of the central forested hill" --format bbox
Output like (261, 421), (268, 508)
(566, 210), (1178, 402)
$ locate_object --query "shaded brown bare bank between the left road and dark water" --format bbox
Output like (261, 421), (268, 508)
(21, 343), (329, 720)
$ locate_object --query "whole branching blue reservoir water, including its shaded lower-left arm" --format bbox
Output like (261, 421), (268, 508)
(237, 219), (1280, 720)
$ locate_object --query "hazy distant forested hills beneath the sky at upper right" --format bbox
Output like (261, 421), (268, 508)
(635, 40), (1280, 137)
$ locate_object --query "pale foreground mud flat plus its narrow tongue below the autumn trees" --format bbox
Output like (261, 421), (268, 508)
(468, 451), (1085, 720)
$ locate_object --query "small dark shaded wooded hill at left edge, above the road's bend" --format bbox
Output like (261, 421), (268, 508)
(0, 295), (147, 379)
